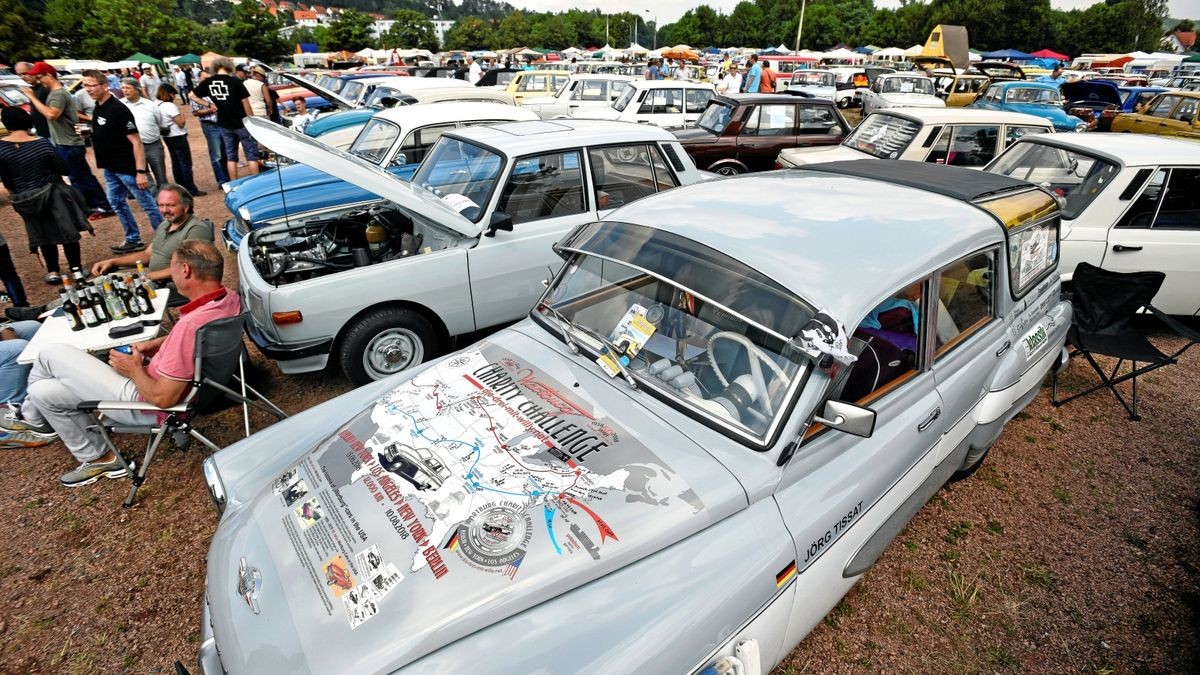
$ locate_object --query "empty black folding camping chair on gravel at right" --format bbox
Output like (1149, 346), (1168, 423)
(1050, 263), (1200, 422)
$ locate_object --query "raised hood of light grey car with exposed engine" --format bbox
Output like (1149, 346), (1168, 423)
(246, 118), (482, 237)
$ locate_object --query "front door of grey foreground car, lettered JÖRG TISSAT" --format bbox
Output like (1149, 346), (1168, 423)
(775, 276), (946, 595)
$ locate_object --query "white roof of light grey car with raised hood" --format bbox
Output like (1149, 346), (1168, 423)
(439, 120), (676, 155)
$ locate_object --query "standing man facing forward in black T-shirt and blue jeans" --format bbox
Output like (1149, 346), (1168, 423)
(83, 70), (162, 253)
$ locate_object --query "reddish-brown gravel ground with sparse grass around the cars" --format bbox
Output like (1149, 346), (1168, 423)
(0, 118), (1200, 673)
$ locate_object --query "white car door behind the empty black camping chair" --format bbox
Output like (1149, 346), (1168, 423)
(1100, 167), (1200, 315)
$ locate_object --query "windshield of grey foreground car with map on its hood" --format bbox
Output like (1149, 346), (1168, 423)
(534, 222), (815, 446)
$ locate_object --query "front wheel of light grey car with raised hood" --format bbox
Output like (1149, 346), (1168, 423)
(338, 307), (438, 386)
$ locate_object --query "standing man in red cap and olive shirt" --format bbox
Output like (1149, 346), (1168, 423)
(23, 61), (116, 220)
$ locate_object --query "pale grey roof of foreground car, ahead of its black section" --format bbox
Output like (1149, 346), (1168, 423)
(606, 160), (1003, 317)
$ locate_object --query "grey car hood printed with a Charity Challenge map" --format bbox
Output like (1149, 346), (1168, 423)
(208, 330), (746, 673)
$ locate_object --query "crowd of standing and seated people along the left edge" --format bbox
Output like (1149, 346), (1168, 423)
(0, 59), (243, 486)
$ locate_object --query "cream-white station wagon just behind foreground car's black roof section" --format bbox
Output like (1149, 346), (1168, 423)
(775, 108), (1054, 168)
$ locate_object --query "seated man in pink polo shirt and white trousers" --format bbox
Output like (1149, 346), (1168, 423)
(0, 240), (241, 488)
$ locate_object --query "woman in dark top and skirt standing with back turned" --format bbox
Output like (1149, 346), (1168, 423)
(0, 106), (95, 284)
